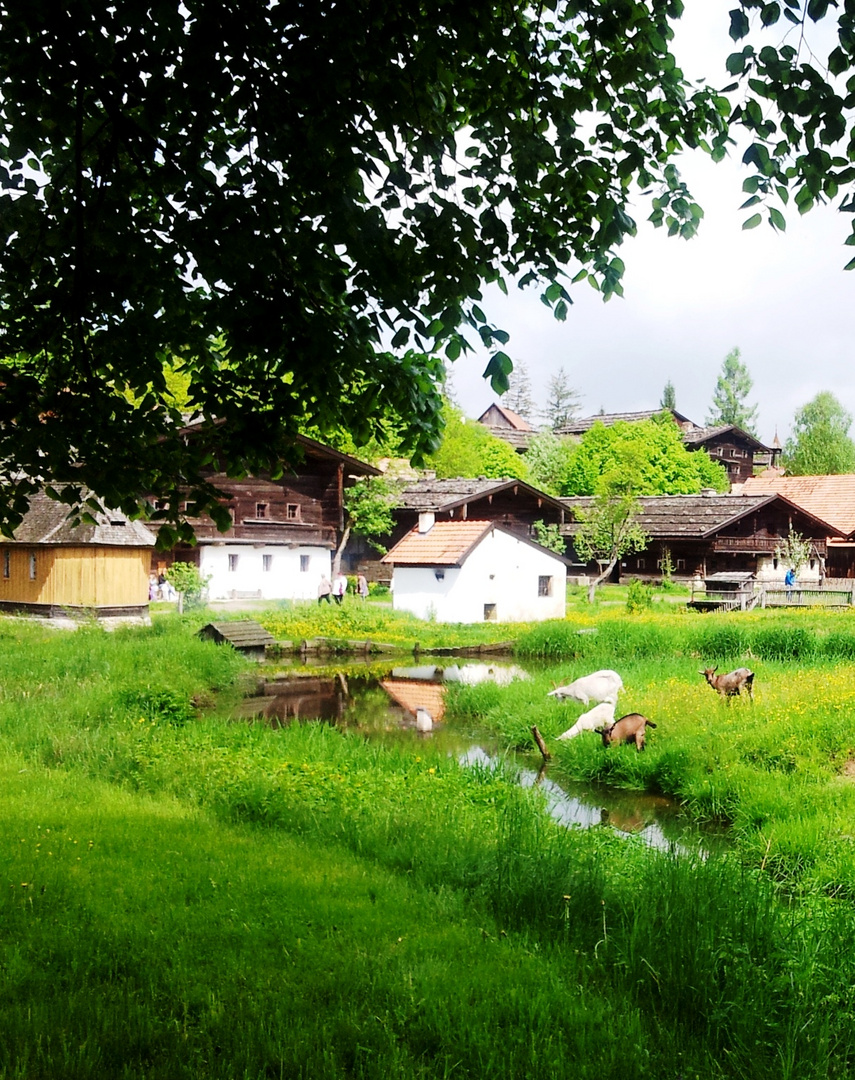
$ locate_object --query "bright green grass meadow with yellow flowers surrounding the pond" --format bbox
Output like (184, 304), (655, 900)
(0, 612), (855, 1080)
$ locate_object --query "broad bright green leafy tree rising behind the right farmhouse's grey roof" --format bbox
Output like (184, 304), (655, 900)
(561, 413), (730, 495)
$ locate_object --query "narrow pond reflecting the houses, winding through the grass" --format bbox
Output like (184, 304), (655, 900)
(234, 658), (729, 852)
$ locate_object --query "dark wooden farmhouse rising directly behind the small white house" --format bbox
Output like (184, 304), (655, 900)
(391, 476), (568, 543)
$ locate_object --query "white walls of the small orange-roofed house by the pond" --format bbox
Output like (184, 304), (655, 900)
(392, 530), (567, 622)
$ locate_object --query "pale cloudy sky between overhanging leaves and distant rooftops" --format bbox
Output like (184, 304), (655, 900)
(452, 0), (855, 443)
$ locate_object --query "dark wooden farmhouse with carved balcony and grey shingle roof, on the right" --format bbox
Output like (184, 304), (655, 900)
(562, 494), (842, 583)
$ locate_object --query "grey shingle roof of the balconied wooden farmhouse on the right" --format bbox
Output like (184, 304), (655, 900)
(561, 494), (842, 539)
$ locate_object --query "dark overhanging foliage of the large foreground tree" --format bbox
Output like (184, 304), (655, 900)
(0, 0), (855, 527)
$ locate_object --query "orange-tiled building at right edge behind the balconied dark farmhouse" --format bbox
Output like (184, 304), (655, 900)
(743, 471), (855, 578)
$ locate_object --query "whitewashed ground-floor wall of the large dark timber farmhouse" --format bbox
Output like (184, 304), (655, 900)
(199, 543), (333, 600)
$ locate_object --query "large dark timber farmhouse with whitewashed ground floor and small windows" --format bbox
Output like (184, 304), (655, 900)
(152, 427), (379, 600)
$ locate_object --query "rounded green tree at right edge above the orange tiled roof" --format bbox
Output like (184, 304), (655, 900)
(783, 390), (855, 476)
